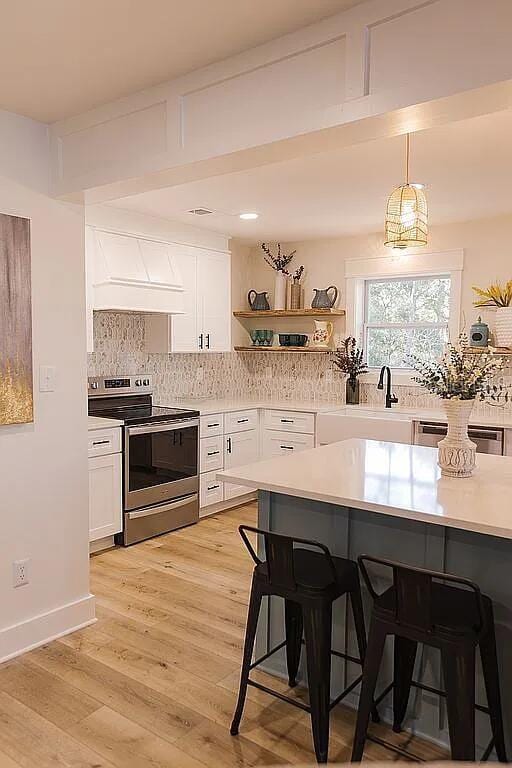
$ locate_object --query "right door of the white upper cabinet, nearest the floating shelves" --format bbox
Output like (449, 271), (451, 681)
(197, 250), (231, 352)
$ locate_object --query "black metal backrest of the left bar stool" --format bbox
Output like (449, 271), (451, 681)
(238, 525), (336, 591)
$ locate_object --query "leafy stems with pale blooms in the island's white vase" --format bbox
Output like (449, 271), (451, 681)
(409, 333), (503, 400)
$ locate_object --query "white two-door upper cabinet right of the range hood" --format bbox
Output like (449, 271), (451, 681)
(146, 245), (231, 352)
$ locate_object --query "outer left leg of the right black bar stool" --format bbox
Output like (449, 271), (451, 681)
(351, 618), (386, 763)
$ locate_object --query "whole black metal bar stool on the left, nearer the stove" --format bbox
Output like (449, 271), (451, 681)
(231, 525), (378, 763)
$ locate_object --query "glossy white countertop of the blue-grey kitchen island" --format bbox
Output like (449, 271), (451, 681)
(217, 439), (512, 539)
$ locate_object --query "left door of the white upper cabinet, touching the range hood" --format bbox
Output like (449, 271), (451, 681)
(170, 245), (200, 352)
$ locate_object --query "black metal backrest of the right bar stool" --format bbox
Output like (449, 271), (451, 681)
(357, 555), (486, 632)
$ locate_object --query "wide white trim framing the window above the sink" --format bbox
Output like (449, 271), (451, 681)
(345, 248), (464, 386)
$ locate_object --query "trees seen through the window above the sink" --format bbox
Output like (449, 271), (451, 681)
(364, 275), (451, 368)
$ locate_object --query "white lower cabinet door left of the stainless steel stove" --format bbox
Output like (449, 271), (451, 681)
(89, 453), (123, 541)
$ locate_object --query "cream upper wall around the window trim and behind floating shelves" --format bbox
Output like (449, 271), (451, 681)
(243, 214), (512, 340)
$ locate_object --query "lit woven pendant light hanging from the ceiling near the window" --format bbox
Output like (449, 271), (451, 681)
(384, 134), (428, 248)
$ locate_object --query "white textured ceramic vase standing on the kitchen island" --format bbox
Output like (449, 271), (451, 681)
(437, 399), (476, 477)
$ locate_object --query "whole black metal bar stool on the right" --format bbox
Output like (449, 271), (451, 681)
(352, 555), (507, 762)
